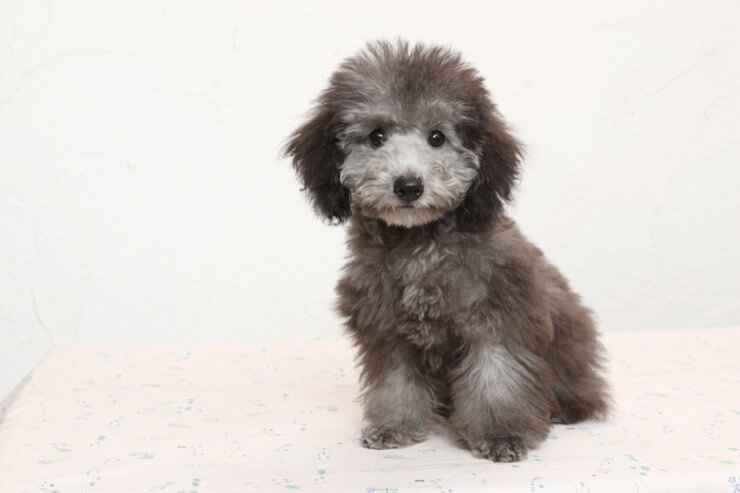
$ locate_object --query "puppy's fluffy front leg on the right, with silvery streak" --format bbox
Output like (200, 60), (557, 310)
(450, 342), (552, 462)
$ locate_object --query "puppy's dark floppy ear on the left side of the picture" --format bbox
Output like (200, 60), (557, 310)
(284, 102), (350, 224)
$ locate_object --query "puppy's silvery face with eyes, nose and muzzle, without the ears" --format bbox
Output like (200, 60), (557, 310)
(339, 102), (479, 227)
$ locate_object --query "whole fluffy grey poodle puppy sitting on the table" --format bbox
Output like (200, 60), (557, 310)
(285, 41), (609, 462)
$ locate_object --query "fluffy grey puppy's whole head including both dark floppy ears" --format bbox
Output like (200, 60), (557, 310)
(285, 42), (521, 229)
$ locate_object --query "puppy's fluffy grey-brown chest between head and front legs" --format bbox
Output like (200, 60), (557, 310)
(337, 228), (487, 348)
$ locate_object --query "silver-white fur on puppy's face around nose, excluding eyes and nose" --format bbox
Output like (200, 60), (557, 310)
(340, 127), (478, 227)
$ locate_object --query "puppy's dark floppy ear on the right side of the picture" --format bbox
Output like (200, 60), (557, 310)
(457, 106), (522, 230)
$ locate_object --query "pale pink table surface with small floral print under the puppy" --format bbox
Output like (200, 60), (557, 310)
(0, 328), (740, 493)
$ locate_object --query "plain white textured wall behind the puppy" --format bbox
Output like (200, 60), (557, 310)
(0, 0), (740, 394)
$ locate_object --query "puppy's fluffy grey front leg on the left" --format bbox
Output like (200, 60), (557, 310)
(362, 342), (440, 449)
